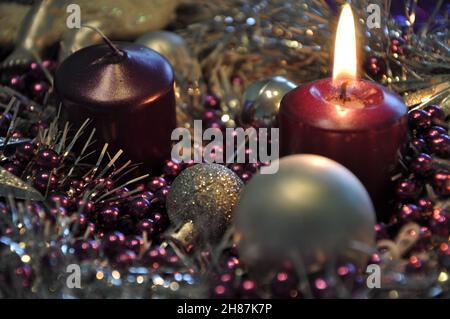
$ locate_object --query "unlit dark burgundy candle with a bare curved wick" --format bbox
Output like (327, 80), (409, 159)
(55, 35), (176, 172)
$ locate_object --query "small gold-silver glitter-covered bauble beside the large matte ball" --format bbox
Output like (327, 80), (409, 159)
(167, 164), (243, 243)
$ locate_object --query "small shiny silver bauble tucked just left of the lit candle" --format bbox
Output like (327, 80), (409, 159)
(240, 76), (297, 127)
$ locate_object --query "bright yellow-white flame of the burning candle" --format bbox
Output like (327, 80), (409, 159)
(333, 3), (357, 85)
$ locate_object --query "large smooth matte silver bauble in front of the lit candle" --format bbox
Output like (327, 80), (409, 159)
(235, 155), (375, 274)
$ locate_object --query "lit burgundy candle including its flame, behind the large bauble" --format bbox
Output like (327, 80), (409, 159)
(279, 5), (407, 218)
